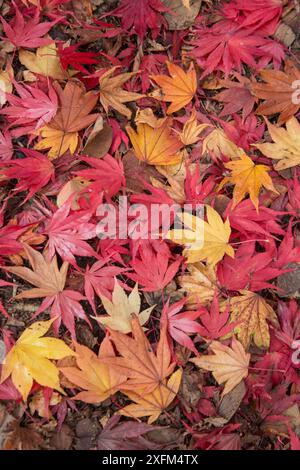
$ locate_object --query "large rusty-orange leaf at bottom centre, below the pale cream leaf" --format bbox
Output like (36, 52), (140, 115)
(102, 315), (175, 394)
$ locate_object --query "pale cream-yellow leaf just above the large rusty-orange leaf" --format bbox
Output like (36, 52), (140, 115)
(93, 280), (155, 334)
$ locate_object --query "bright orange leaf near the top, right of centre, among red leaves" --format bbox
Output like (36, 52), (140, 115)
(150, 61), (197, 114)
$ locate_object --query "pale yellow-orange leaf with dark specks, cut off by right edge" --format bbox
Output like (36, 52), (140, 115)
(253, 117), (300, 171)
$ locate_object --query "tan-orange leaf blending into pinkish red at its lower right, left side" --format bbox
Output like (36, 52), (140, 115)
(5, 244), (88, 338)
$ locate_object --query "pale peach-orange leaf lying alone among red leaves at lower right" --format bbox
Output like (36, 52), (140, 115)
(190, 338), (250, 396)
